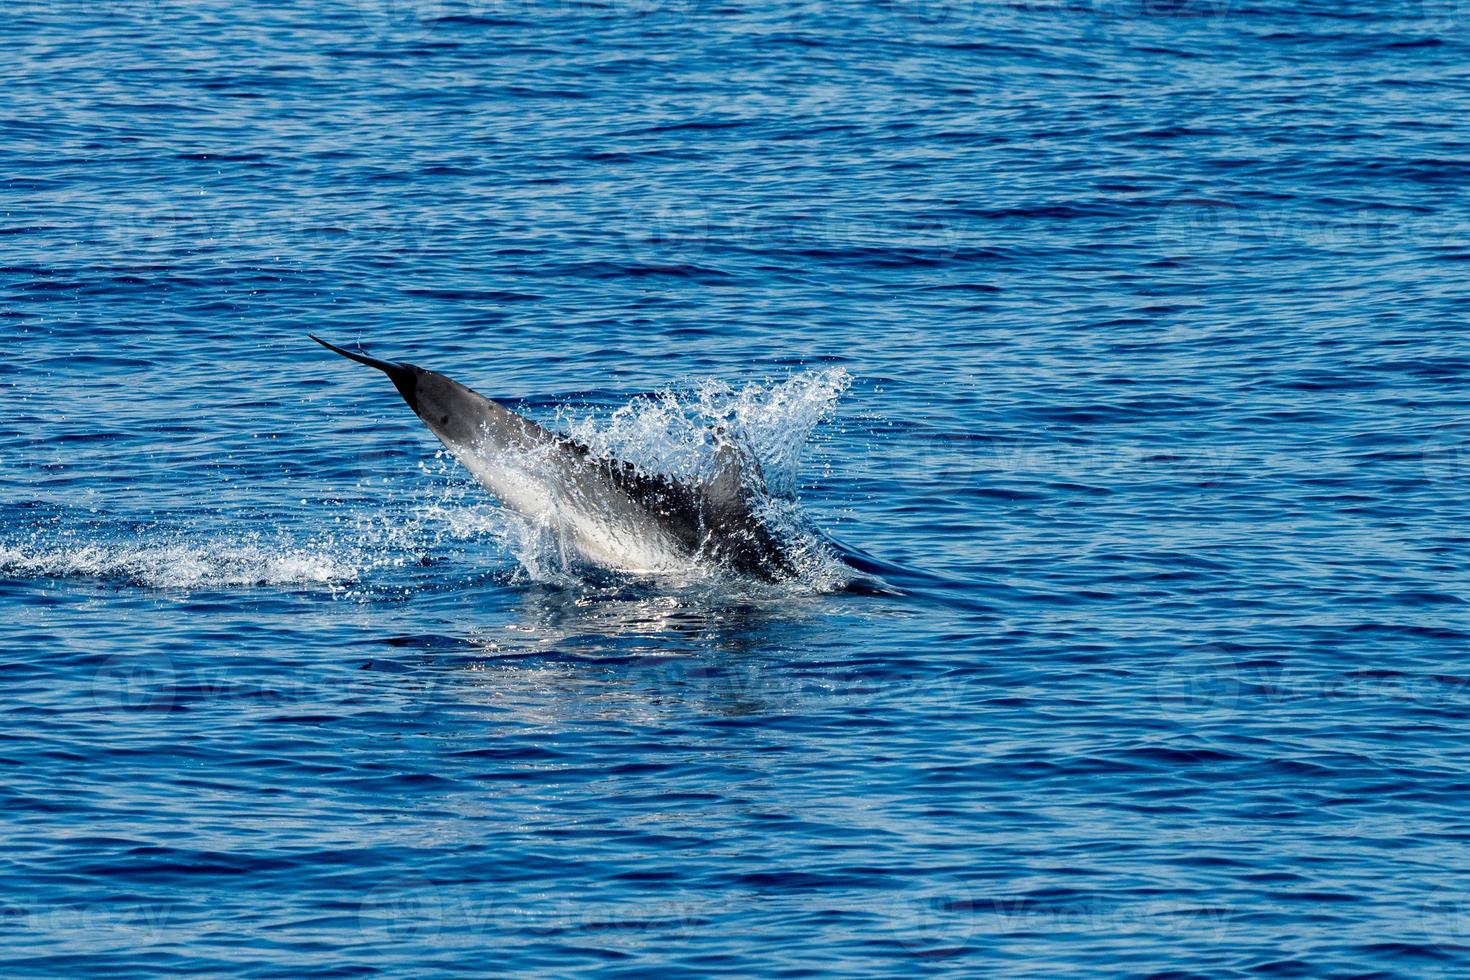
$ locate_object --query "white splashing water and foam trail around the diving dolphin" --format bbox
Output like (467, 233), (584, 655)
(0, 369), (851, 601)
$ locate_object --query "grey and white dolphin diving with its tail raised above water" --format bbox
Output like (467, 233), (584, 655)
(309, 335), (795, 580)
